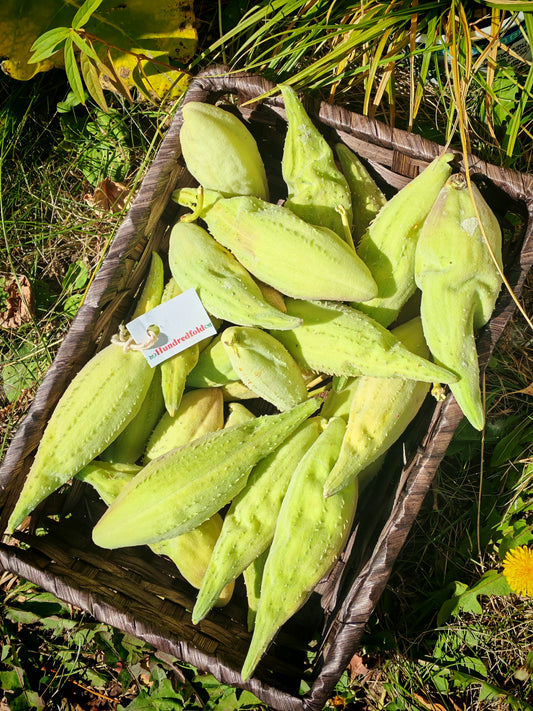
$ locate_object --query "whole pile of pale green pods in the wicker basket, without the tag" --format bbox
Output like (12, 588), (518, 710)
(8, 86), (502, 679)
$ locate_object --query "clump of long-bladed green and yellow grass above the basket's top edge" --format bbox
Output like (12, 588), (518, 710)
(195, 0), (533, 170)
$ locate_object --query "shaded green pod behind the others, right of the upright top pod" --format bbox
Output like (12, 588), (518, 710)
(335, 143), (387, 244)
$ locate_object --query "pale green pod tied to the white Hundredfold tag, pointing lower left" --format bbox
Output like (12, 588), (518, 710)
(7, 344), (153, 533)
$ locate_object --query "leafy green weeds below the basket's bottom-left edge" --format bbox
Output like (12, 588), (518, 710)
(0, 574), (266, 711)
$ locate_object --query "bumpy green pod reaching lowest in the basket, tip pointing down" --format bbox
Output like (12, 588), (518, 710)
(241, 417), (357, 681)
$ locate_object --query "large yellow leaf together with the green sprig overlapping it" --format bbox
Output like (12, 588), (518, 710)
(0, 0), (197, 111)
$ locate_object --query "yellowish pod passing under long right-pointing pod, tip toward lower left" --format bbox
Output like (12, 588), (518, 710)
(324, 318), (430, 496)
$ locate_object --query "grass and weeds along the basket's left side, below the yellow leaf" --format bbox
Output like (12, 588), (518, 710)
(0, 72), (176, 456)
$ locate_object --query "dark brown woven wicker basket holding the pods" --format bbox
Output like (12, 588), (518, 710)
(0, 67), (533, 711)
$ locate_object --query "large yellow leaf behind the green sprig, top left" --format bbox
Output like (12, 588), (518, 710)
(0, 0), (198, 100)
